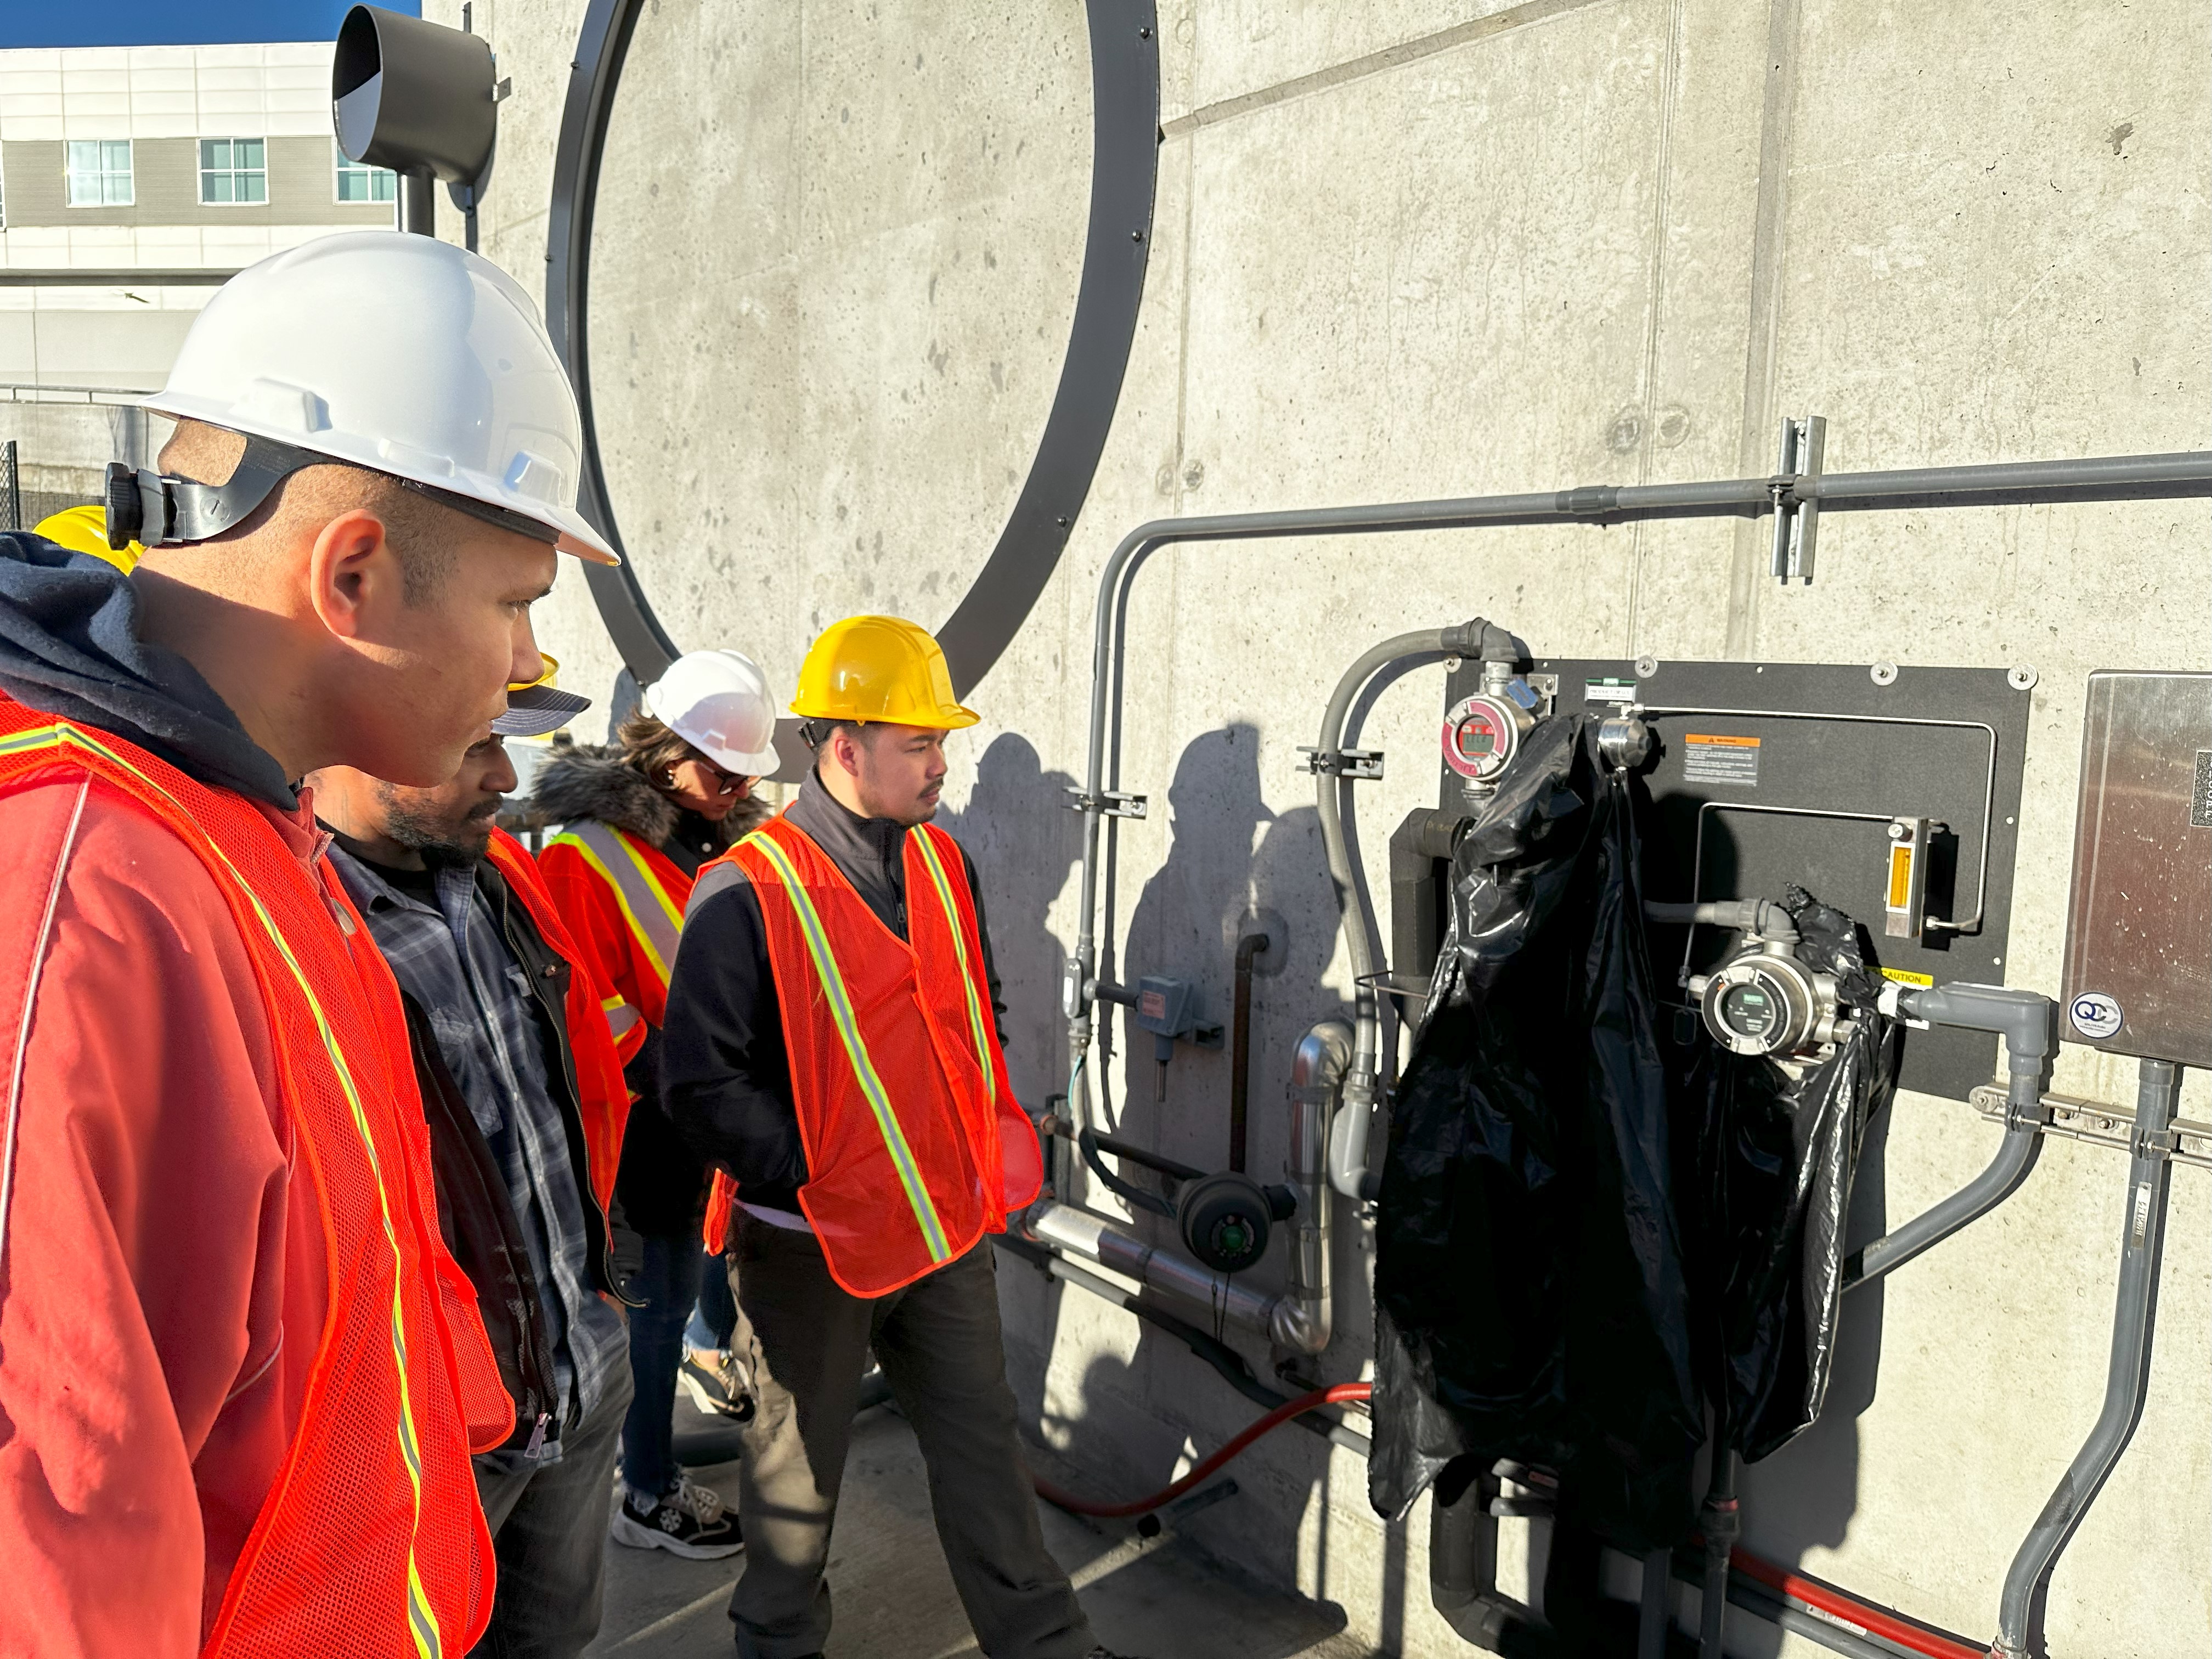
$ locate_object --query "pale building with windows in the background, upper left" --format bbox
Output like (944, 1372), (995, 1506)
(0, 42), (396, 522)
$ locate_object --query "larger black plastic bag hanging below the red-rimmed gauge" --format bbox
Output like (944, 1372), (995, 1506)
(1367, 714), (1703, 1553)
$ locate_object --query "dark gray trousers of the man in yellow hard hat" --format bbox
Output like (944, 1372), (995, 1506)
(730, 1212), (1095, 1659)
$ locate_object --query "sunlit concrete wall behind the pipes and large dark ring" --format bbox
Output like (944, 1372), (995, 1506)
(427, 0), (2212, 1659)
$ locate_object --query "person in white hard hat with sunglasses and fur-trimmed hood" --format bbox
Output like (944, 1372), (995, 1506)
(531, 650), (776, 1560)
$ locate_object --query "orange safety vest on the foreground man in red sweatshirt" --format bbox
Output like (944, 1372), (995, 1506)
(0, 697), (515, 1659)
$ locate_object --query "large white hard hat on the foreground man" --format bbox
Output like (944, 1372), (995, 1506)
(144, 230), (619, 564)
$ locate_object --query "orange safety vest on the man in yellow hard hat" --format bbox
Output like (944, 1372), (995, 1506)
(723, 816), (1044, 1296)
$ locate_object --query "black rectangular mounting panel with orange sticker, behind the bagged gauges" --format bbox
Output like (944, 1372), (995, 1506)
(1433, 659), (2035, 1099)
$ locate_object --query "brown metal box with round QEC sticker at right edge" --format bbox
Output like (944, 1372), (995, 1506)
(2059, 670), (2212, 1066)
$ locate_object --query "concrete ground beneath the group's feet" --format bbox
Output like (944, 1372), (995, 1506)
(591, 1402), (1372, 1659)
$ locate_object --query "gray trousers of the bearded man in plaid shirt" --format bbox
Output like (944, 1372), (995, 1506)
(469, 1365), (630, 1659)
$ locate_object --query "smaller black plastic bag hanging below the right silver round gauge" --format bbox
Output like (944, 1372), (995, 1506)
(1677, 887), (1903, 1462)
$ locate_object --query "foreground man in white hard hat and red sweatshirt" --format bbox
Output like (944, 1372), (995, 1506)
(0, 232), (613, 1659)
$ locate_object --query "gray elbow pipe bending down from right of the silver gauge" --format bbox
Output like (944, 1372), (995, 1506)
(1843, 984), (2057, 1290)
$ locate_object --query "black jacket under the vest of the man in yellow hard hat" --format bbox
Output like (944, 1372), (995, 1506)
(662, 774), (1007, 1212)
